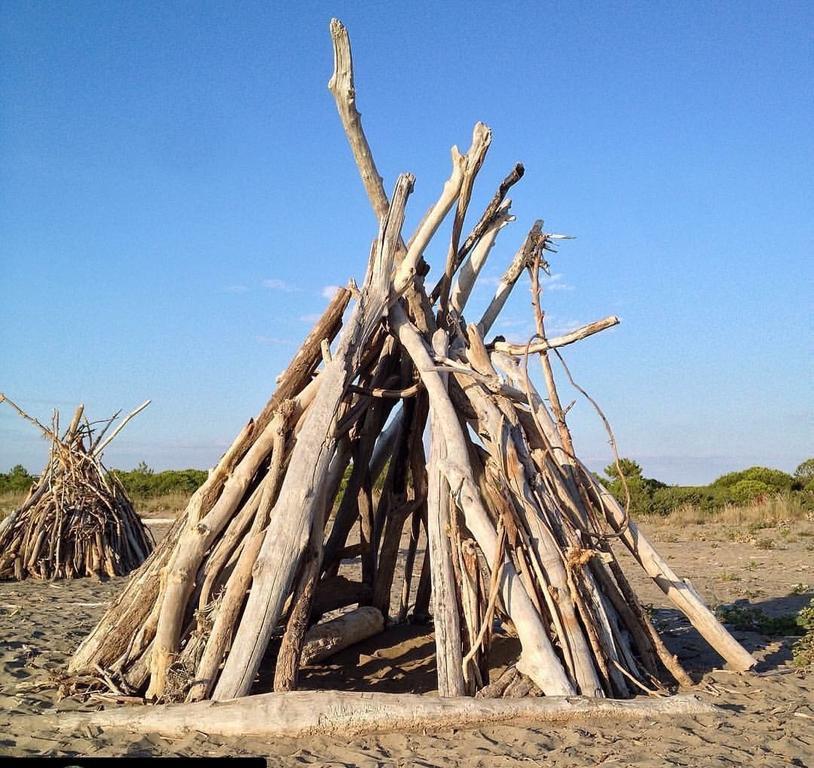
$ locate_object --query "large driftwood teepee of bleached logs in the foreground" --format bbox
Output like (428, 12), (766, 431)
(71, 21), (755, 732)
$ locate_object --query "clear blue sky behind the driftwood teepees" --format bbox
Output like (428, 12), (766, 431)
(0, 0), (814, 483)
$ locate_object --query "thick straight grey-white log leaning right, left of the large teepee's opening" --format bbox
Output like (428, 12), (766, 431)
(213, 174), (414, 700)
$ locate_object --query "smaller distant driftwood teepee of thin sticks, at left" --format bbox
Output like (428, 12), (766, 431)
(0, 395), (153, 580)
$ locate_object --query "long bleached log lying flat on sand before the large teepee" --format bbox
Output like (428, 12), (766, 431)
(49, 691), (717, 738)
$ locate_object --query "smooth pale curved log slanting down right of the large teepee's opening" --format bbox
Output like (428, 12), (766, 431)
(390, 304), (575, 695)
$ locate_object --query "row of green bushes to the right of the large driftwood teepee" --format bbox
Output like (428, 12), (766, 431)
(599, 459), (814, 515)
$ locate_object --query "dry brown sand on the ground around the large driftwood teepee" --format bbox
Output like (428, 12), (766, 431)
(0, 524), (814, 768)
